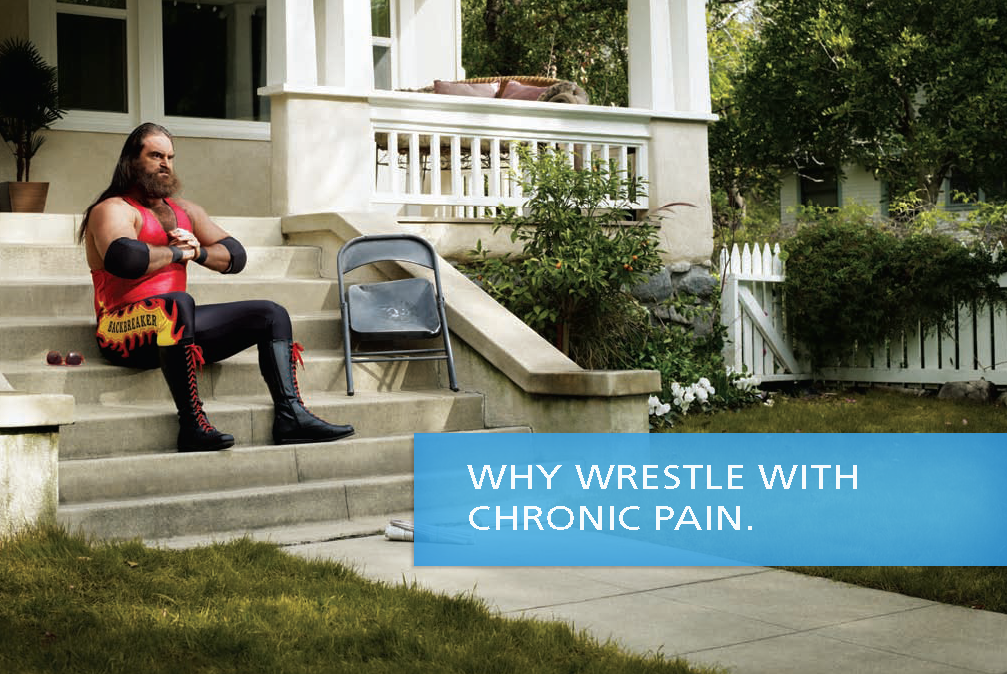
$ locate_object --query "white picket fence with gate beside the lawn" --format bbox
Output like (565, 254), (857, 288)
(720, 244), (1007, 385)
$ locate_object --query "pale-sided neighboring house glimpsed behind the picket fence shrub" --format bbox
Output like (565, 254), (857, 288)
(779, 164), (1007, 223)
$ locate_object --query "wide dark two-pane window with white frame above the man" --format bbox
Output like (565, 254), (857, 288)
(38, 0), (270, 140)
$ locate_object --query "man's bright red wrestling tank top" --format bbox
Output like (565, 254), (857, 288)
(91, 196), (192, 320)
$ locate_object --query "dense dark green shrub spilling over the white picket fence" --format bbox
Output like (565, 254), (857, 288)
(783, 212), (1007, 368)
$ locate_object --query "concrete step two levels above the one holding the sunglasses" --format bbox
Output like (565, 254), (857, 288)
(0, 274), (339, 316)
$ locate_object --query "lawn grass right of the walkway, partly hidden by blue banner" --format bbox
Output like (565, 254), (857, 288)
(671, 382), (1007, 613)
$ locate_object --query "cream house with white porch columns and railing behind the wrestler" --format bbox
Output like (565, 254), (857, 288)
(0, 0), (714, 264)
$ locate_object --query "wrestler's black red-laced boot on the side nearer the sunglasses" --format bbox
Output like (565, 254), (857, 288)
(159, 344), (235, 451)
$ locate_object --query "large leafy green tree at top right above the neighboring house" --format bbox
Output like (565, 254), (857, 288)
(737, 0), (1007, 206)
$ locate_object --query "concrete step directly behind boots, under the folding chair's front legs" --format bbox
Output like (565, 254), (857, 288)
(59, 389), (485, 459)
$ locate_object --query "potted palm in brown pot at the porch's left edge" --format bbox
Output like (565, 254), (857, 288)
(0, 37), (63, 213)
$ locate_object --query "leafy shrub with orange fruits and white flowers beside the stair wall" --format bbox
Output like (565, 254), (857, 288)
(462, 146), (756, 427)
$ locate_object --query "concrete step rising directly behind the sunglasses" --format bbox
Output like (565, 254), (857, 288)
(0, 310), (342, 360)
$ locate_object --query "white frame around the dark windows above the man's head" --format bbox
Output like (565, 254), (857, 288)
(28, 0), (270, 140)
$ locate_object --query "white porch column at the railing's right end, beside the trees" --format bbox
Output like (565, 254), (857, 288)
(628, 0), (710, 113)
